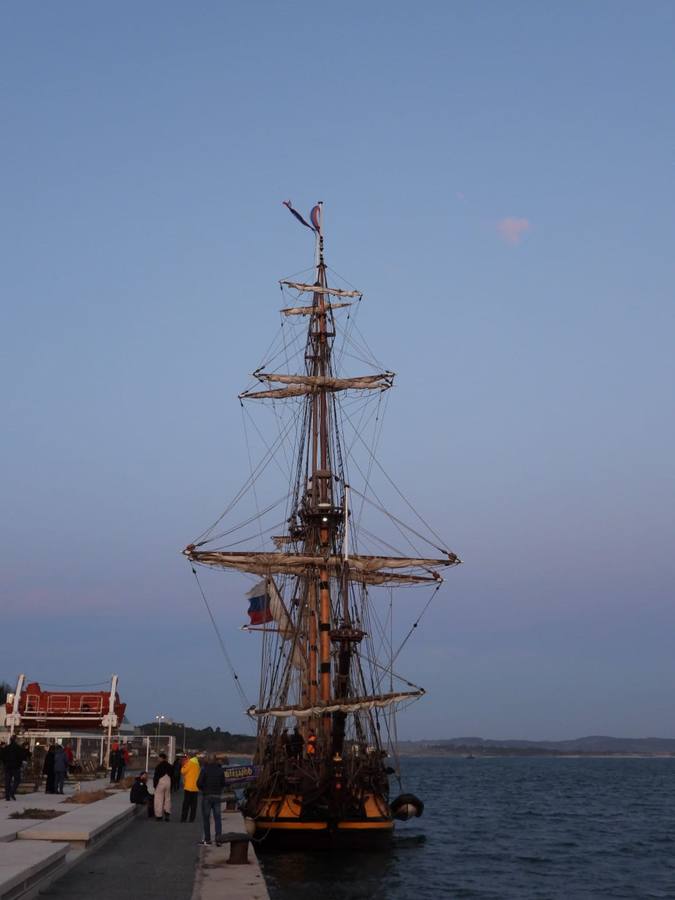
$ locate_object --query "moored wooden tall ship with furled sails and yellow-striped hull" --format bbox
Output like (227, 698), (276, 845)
(183, 201), (461, 849)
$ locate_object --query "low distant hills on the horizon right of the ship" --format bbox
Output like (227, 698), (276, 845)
(398, 735), (675, 756)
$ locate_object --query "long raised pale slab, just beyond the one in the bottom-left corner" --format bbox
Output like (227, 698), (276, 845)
(17, 791), (136, 847)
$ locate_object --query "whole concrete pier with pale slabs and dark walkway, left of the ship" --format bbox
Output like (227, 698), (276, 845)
(0, 782), (269, 900)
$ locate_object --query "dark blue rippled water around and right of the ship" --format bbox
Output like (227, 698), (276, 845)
(262, 759), (675, 900)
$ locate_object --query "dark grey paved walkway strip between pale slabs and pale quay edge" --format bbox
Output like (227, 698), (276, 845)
(40, 792), (201, 900)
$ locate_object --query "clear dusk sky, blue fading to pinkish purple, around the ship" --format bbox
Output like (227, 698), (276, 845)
(0, 0), (675, 739)
